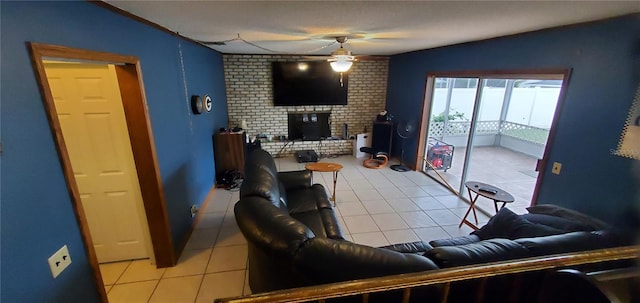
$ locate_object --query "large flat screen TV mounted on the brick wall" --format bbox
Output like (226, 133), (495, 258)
(271, 61), (349, 106)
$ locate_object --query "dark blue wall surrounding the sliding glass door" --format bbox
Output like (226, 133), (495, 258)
(387, 14), (640, 227)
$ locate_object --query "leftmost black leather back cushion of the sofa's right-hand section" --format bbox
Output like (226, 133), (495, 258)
(424, 239), (531, 268)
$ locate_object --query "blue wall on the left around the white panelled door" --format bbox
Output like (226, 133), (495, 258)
(0, 1), (227, 302)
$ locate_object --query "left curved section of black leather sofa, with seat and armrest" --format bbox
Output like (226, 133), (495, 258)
(234, 150), (438, 292)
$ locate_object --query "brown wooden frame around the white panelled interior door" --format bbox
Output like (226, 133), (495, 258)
(27, 42), (176, 302)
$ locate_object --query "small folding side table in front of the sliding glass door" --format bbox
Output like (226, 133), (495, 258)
(458, 181), (515, 229)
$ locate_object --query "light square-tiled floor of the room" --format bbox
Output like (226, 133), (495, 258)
(100, 156), (508, 303)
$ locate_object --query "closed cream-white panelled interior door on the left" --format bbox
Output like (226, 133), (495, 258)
(45, 62), (151, 263)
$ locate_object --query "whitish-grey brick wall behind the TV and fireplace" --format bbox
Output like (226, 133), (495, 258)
(223, 55), (389, 155)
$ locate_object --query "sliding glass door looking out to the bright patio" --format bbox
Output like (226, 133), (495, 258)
(421, 74), (564, 213)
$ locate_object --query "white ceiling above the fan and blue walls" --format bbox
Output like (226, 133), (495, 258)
(105, 0), (640, 55)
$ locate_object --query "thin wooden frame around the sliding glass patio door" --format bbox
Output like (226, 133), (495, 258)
(414, 68), (572, 206)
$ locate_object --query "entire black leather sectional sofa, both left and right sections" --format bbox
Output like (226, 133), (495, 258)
(234, 150), (625, 302)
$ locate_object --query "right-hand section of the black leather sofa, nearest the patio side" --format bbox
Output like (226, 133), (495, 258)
(425, 205), (633, 268)
